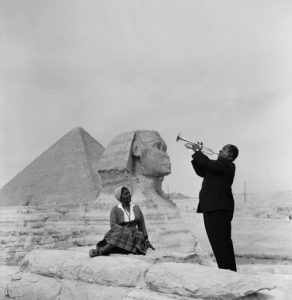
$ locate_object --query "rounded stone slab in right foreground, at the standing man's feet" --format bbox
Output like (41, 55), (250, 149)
(146, 263), (275, 300)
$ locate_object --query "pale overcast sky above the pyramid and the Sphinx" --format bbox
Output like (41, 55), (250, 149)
(0, 0), (292, 196)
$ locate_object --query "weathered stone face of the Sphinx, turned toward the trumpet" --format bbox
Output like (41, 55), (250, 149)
(132, 131), (171, 177)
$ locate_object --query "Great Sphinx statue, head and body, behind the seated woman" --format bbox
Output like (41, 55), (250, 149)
(96, 130), (209, 253)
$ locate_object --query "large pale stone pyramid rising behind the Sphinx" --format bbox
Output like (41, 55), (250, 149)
(0, 127), (105, 205)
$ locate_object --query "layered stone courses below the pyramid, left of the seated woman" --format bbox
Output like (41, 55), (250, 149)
(0, 205), (109, 265)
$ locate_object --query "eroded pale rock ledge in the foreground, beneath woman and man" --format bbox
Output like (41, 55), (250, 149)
(0, 249), (282, 300)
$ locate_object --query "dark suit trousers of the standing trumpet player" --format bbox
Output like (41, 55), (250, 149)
(203, 210), (236, 272)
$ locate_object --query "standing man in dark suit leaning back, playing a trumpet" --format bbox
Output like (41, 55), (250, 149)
(190, 144), (238, 272)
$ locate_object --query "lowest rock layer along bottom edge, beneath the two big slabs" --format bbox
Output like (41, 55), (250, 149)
(4, 273), (291, 300)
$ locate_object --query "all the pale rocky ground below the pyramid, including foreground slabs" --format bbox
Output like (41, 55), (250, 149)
(0, 194), (292, 300)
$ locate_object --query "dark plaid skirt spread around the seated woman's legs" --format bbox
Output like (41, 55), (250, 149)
(96, 226), (147, 255)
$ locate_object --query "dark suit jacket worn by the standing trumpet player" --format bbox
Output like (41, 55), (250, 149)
(192, 151), (235, 213)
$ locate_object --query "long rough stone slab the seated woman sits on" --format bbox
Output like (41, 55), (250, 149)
(22, 250), (150, 287)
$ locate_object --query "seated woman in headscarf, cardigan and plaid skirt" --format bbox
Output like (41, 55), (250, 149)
(89, 187), (155, 257)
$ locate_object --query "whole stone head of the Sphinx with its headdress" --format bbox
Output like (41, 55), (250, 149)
(98, 130), (171, 195)
